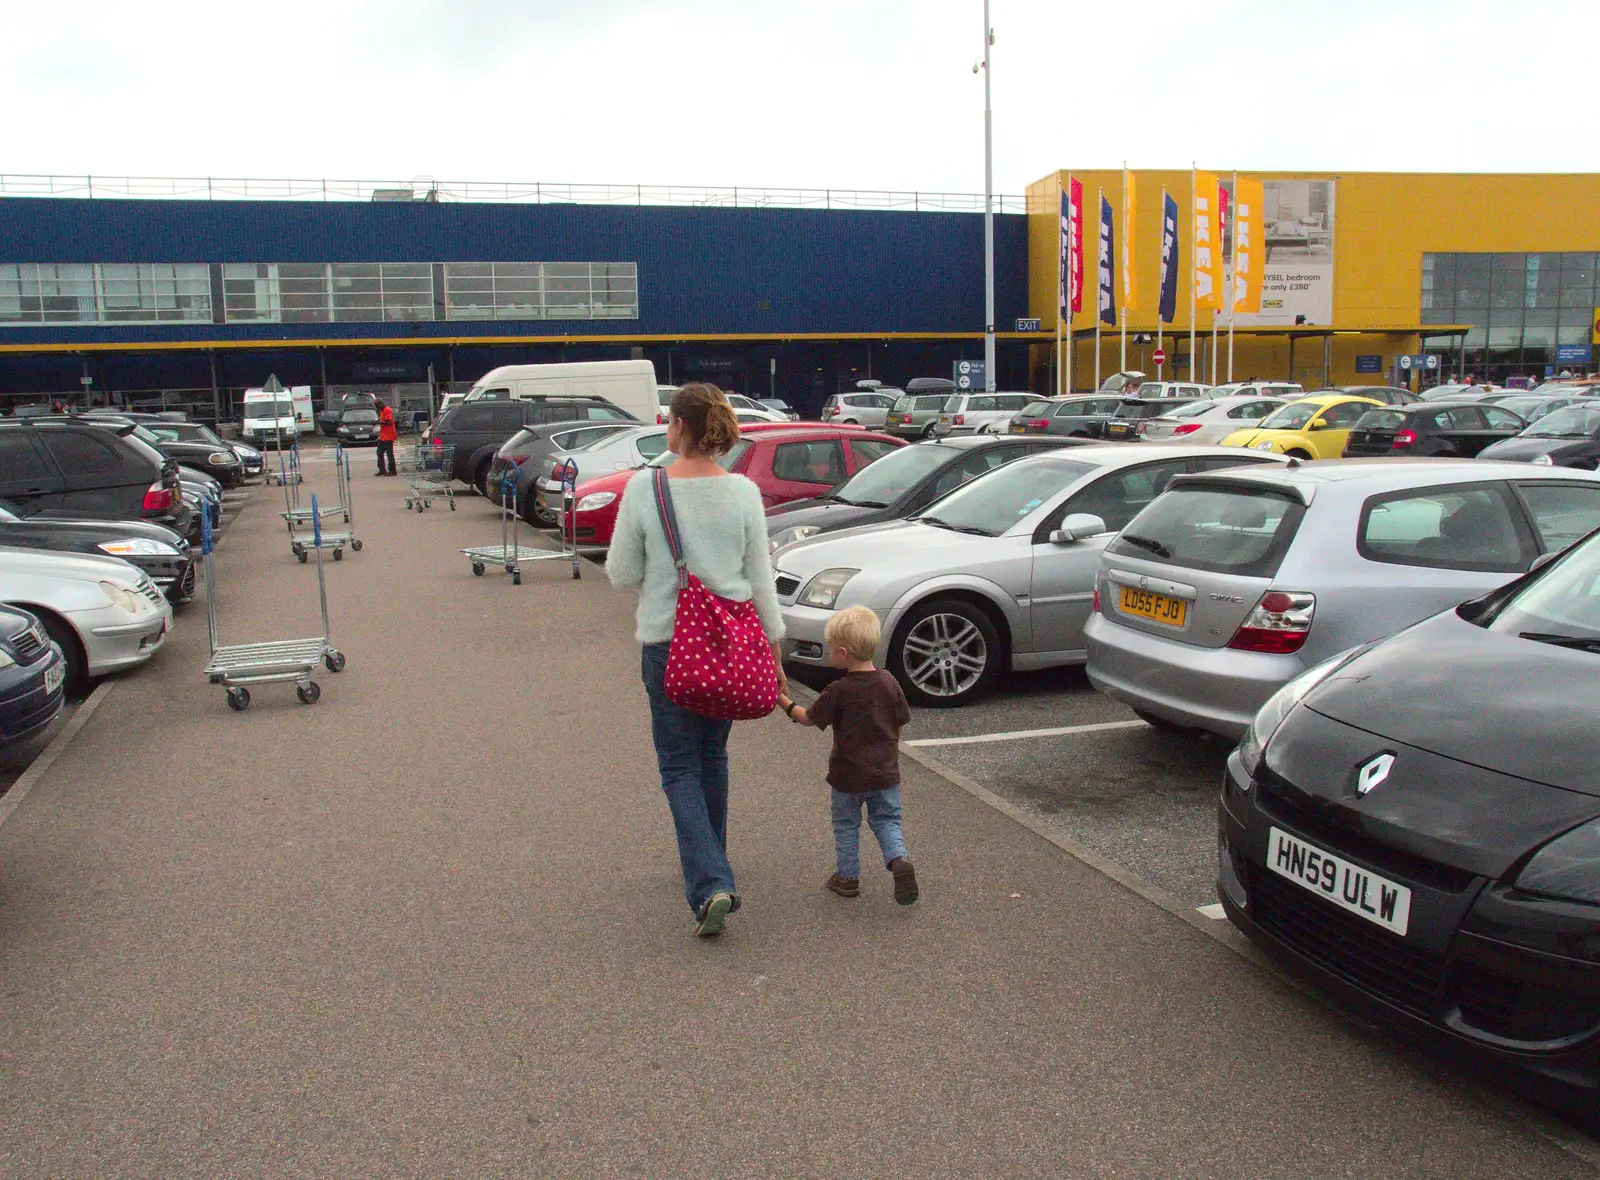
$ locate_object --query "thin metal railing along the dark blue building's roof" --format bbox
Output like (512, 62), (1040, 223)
(0, 173), (1027, 213)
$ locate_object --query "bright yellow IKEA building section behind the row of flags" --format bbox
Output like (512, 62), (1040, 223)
(1027, 169), (1600, 390)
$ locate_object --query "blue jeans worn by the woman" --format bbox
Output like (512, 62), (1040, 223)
(640, 643), (733, 915)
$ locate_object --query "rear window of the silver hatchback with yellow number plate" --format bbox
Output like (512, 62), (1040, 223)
(1106, 484), (1306, 577)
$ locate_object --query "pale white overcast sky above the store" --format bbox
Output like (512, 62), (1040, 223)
(0, 0), (1600, 192)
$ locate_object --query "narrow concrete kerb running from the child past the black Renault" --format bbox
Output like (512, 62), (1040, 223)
(789, 681), (1600, 1174)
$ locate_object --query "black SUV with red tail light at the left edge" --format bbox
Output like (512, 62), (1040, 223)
(0, 416), (194, 536)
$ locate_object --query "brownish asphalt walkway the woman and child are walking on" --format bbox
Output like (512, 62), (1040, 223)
(0, 468), (1594, 1180)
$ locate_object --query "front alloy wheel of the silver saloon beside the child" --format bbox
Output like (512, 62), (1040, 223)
(890, 598), (1002, 708)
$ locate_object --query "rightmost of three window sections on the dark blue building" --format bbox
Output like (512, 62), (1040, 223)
(445, 262), (638, 320)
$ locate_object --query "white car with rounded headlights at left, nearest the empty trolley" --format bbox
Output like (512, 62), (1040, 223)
(0, 547), (173, 692)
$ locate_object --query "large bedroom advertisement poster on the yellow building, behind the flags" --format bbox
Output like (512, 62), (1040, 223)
(1221, 181), (1334, 328)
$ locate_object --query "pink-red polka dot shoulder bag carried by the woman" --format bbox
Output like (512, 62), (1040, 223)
(654, 467), (778, 721)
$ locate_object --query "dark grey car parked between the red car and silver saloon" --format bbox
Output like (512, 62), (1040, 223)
(766, 435), (1091, 550)
